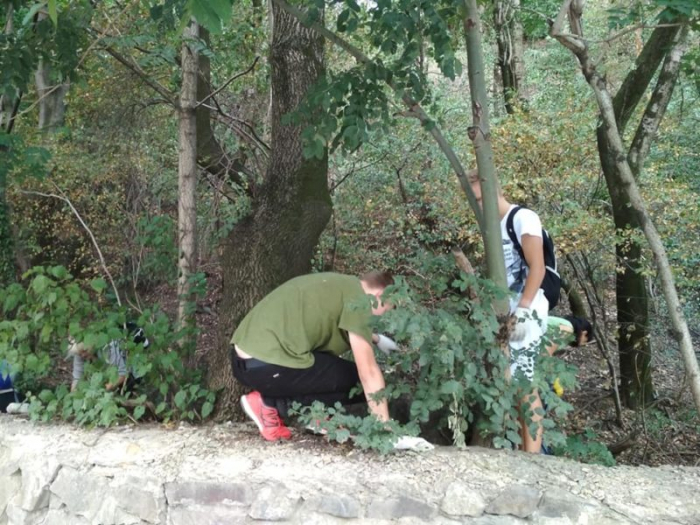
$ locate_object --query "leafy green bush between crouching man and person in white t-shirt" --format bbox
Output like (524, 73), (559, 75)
(301, 254), (575, 451)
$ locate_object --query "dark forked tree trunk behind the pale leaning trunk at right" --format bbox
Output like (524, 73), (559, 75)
(597, 19), (685, 408)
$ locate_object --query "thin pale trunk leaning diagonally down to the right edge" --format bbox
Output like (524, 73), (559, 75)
(551, 0), (700, 411)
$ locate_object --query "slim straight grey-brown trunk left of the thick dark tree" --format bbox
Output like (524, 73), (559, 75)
(177, 20), (199, 336)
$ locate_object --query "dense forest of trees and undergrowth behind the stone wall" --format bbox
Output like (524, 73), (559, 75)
(0, 0), (700, 465)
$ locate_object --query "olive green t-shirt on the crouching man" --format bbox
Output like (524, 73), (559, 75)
(231, 273), (372, 368)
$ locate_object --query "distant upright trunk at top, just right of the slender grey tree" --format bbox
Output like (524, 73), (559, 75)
(494, 0), (525, 114)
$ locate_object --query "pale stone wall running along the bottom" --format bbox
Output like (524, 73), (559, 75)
(0, 415), (700, 525)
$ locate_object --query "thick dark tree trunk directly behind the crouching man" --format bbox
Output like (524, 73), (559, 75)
(207, 5), (332, 417)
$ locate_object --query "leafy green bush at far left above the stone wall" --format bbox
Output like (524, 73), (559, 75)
(0, 266), (215, 426)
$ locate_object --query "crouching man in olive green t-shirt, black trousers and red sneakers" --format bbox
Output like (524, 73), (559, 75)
(231, 272), (393, 441)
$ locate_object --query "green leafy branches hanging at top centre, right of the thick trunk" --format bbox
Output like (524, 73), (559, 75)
(293, 0), (462, 157)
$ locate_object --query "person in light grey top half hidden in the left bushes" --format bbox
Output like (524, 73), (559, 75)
(68, 323), (149, 392)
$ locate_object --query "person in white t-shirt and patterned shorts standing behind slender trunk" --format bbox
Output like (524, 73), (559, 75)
(468, 170), (549, 453)
